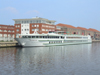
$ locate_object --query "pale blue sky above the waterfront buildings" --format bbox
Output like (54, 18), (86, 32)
(0, 0), (100, 31)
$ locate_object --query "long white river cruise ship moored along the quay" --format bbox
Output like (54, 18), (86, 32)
(15, 32), (92, 47)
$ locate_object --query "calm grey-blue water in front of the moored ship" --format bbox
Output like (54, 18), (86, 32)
(0, 42), (100, 75)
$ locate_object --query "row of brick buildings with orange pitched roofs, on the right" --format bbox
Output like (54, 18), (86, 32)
(56, 23), (100, 40)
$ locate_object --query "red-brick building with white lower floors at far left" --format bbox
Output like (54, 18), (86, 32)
(0, 24), (15, 41)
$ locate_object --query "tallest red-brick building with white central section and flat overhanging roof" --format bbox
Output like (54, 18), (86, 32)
(13, 17), (56, 36)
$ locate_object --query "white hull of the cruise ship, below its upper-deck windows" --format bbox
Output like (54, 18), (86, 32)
(15, 38), (92, 47)
